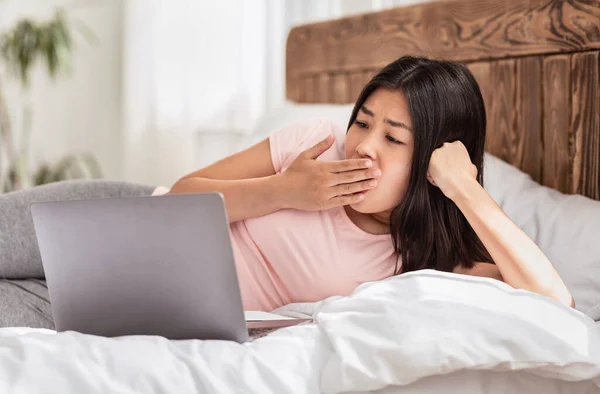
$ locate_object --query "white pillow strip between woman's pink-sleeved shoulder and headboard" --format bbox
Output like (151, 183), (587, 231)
(237, 101), (354, 148)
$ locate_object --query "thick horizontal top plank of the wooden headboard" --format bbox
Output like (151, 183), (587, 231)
(287, 0), (600, 87)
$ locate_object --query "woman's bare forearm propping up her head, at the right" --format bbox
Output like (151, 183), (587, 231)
(453, 179), (574, 306)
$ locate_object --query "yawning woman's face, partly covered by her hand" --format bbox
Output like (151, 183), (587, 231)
(346, 88), (414, 217)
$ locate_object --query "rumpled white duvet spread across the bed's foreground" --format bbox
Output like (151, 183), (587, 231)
(0, 270), (600, 394)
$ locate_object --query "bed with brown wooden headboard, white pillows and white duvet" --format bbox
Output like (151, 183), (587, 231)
(0, 0), (600, 394)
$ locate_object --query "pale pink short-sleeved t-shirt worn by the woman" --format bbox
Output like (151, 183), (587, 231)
(230, 119), (396, 311)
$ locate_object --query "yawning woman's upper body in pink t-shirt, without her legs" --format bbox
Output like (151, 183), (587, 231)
(169, 57), (574, 310)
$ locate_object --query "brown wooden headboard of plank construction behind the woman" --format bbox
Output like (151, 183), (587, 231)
(286, 0), (600, 200)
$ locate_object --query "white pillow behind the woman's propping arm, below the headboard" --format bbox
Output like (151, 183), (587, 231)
(484, 154), (600, 321)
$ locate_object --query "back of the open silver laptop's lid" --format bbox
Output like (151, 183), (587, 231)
(31, 193), (248, 342)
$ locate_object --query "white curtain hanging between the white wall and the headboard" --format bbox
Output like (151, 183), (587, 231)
(123, 0), (416, 185)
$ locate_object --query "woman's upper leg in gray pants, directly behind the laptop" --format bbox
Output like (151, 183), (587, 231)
(0, 180), (155, 279)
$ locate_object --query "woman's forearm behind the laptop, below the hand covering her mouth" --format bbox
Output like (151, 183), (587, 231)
(169, 175), (285, 223)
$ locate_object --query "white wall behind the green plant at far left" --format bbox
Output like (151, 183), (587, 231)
(0, 0), (123, 179)
